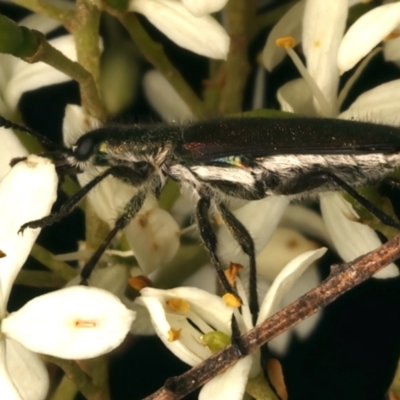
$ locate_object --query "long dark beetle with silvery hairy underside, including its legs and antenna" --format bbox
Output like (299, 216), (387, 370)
(0, 118), (400, 315)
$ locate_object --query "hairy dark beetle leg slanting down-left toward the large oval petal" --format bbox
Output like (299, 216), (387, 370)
(81, 191), (146, 285)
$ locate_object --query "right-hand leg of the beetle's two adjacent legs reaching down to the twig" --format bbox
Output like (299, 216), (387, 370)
(218, 203), (260, 324)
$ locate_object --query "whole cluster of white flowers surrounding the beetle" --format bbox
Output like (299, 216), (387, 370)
(0, 0), (400, 400)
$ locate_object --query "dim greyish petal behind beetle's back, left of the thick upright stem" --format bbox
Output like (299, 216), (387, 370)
(143, 70), (194, 122)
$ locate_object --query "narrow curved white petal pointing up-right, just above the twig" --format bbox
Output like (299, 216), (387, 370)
(257, 247), (327, 324)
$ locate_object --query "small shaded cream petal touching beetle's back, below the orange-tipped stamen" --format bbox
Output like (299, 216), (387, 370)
(277, 78), (317, 117)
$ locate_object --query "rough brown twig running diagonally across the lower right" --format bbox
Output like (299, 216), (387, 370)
(145, 235), (400, 400)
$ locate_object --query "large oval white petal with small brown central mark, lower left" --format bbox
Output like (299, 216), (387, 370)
(2, 286), (135, 359)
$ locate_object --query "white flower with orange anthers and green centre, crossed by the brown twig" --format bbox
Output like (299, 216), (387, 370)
(136, 249), (326, 400)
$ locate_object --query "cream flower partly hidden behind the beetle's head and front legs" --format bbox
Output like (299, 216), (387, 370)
(63, 105), (179, 274)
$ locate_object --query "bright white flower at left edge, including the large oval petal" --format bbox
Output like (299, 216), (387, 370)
(0, 156), (134, 400)
